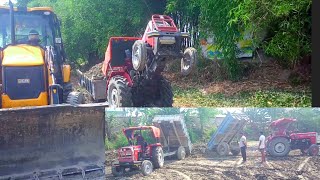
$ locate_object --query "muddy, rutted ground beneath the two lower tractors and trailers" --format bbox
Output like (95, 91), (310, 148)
(106, 143), (320, 180)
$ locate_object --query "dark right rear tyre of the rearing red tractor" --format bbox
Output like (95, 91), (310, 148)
(157, 76), (173, 107)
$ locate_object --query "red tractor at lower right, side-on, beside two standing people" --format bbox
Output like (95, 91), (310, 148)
(267, 118), (320, 157)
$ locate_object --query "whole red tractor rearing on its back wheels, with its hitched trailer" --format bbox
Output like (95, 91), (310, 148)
(78, 15), (197, 107)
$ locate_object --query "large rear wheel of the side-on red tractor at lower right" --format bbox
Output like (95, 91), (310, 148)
(269, 137), (290, 157)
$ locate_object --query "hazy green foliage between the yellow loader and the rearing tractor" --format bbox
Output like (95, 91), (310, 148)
(21, 0), (165, 64)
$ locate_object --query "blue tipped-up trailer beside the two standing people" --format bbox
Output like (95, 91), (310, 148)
(208, 113), (249, 156)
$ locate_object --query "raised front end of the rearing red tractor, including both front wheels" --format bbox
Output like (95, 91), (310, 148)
(132, 14), (197, 78)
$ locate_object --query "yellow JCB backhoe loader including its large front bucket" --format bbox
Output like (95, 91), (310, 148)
(0, 1), (105, 180)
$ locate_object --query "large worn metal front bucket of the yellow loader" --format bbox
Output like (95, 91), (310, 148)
(0, 104), (105, 180)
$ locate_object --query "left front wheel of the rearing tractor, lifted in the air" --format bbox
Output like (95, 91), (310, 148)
(132, 40), (148, 71)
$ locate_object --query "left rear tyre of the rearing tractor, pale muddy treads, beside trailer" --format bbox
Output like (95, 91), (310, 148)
(107, 76), (132, 107)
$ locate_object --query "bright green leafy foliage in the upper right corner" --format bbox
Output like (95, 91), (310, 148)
(230, 0), (311, 66)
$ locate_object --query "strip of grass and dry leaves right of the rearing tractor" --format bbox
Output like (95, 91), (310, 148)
(173, 86), (311, 107)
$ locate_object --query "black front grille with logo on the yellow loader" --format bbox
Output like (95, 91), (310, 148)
(2, 66), (45, 100)
